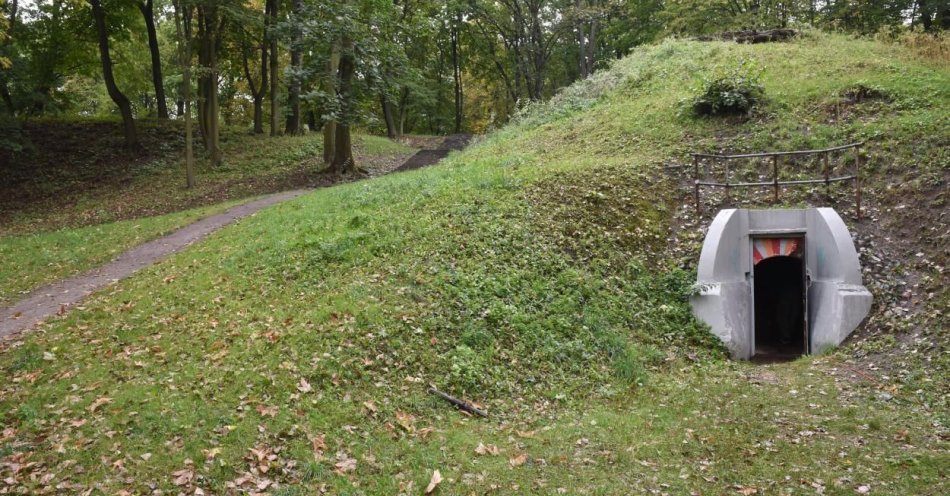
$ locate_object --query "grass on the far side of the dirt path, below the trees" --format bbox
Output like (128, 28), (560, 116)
(0, 132), (414, 305)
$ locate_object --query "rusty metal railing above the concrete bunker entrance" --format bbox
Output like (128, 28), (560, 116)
(691, 142), (864, 219)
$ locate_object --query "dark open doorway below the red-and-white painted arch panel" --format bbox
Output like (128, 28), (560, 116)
(753, 256), (808, 362)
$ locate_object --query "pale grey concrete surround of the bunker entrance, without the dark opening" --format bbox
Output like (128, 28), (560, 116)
(691, 208), (872, 359)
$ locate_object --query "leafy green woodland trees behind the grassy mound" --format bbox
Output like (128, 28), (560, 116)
(0, 0), (950, 164)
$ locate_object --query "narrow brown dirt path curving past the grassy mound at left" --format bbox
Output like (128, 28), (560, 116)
(0, 190), (309, 338)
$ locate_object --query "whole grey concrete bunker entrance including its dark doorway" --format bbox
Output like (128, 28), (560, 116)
(691, 208), (872, 361)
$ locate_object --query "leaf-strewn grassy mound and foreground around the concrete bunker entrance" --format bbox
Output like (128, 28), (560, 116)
(0, 36), (950, 494)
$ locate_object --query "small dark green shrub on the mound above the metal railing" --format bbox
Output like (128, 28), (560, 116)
(692, 59), (765, 115)
